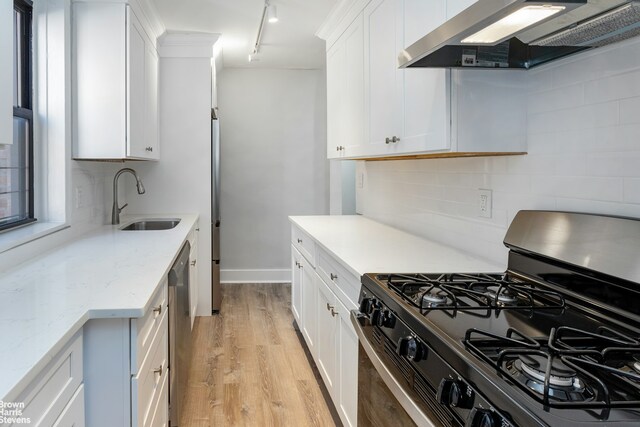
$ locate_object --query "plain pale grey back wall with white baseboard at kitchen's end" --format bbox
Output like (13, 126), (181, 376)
(218, 69), (328, 282)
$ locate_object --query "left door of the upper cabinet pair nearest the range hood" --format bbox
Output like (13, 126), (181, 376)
(364, 0), (403, 155)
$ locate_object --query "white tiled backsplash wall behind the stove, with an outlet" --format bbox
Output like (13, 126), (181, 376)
(357, 38), (640, 262)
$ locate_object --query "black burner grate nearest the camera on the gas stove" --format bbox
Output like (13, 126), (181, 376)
(464, 326), (640, 419)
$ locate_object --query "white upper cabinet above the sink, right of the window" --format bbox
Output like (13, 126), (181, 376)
(72, 2), (159, 160)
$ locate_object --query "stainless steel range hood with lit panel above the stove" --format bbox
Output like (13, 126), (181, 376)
(398, 0), (640, 69)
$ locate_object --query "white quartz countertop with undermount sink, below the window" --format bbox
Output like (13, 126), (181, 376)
(0, 214), (198, 401)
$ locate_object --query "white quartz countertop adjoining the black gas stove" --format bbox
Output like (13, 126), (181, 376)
(289, 215), (507, 276)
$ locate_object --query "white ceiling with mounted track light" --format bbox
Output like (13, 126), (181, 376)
(151, 0), (337, 69)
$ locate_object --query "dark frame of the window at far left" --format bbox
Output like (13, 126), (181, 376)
(0, 0), (36, 231)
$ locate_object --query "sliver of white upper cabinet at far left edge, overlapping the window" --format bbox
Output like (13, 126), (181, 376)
(0, 0), (13, 144)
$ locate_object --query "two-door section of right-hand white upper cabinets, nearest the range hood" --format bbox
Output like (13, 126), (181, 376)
(364, 0), (449, 155)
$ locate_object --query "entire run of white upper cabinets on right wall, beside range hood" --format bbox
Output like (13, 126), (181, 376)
(319, 0), (526, 159)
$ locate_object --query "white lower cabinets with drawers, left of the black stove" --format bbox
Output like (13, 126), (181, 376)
(291, 226), (358, 427)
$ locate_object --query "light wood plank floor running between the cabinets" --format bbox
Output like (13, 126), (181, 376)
(180, 284), (339, 427)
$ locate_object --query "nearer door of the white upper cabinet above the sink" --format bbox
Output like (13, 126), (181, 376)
(127, 6), (147, 157)
